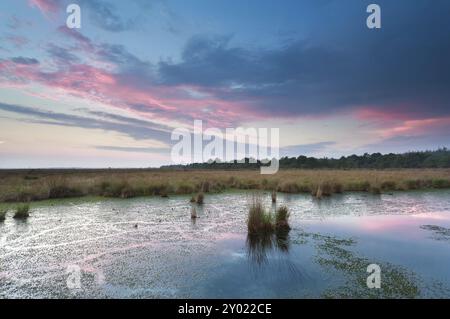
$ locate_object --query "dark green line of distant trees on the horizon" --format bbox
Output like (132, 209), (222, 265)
(161, 148), (450, 169)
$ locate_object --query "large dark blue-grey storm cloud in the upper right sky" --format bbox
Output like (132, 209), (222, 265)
(159, 0), (450, 118)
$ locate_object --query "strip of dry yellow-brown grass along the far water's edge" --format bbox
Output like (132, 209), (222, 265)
(0, 169), (450, 202)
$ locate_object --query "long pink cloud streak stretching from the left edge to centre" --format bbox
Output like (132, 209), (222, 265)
(0, 57), (253, 127)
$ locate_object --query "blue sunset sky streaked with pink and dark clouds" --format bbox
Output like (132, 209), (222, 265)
(0, 0), (450, 168)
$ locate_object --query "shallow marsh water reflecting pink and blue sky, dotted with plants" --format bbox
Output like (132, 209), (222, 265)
(0, 190), (450, 298)
